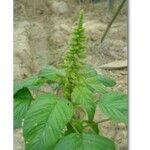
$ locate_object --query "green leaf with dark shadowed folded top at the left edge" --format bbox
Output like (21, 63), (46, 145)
(14, 88), (33, 128)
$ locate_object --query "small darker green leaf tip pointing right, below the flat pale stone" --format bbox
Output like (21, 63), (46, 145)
(98, 74), (116, 87)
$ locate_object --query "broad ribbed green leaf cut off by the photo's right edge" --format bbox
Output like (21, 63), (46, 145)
(98, 92), (128, 123)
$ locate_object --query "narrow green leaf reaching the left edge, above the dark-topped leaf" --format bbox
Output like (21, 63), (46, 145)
(14, 76), (46, 94)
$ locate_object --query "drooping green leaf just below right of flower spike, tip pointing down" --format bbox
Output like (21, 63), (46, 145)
(71, 86), (96, 120)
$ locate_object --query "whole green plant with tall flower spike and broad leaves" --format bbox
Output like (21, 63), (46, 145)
(14, 11), (127, 150)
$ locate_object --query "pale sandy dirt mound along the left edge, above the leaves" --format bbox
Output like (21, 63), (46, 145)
(14, 21), (30, 79)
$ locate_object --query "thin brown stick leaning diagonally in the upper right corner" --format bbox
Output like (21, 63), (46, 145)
(101, 0), (126, 43)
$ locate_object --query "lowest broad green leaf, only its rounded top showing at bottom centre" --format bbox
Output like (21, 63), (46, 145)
(53, 133), (116, 150)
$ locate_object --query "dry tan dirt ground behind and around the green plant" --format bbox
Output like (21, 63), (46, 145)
(14, 0), (128, 150)
